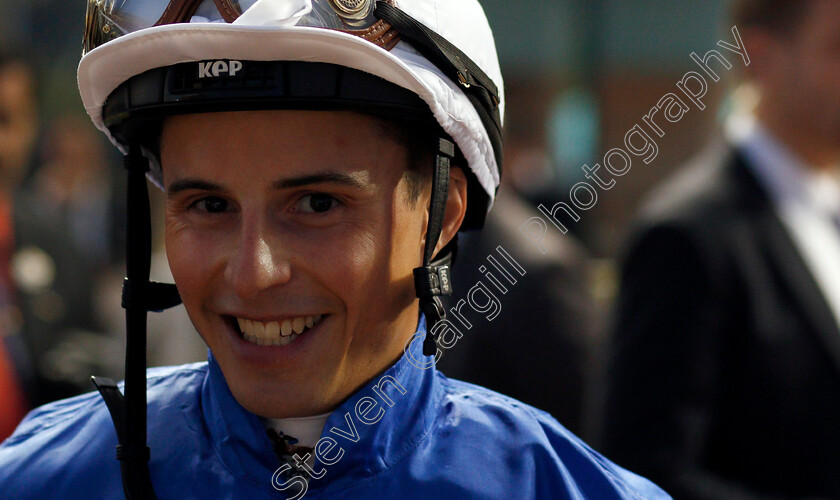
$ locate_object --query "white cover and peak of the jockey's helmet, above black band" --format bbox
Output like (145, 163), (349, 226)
(78, 0), (504, 221)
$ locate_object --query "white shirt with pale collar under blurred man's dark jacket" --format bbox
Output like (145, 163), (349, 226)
(726, 116), (840, 326)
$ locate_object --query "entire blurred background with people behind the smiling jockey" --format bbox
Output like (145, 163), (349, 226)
(14, 0), (840, 499)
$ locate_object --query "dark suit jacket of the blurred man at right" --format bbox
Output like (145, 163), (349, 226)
(601, 143), (840, 500)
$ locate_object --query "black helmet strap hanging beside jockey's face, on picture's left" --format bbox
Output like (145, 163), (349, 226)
(91, 148), (181, 500)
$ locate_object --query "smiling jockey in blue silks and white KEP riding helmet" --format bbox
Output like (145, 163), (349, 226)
(0, 0), (667, 499)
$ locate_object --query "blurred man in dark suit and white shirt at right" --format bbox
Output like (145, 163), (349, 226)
(604, 0), (840, 499)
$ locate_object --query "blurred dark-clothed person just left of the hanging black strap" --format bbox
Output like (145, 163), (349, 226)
(15, 114), (124, 402)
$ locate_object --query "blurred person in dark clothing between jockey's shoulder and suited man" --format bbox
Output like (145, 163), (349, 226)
(437, 177), (602, 435)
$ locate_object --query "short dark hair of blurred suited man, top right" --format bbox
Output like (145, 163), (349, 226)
(731, 0), (812, 35)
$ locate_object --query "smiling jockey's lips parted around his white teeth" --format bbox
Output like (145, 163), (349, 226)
(222, 314), (331, 366)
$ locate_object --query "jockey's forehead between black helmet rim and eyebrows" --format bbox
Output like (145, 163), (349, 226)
(161, 110), (408, 181)
